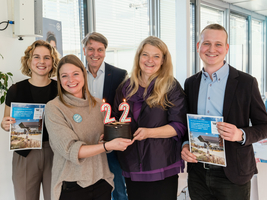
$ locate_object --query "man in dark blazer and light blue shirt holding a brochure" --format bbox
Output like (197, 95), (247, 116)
(182, 24), (267, 200)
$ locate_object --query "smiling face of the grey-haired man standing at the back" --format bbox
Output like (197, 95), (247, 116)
(83, 40), (106, 69)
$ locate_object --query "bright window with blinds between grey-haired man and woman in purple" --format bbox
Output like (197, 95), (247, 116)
(95, 0), (149, 72)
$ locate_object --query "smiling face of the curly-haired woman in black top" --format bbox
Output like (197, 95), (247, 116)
(30, 46), (53, 78)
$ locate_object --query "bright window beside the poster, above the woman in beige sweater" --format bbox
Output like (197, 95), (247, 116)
(43, 0), (82, 59)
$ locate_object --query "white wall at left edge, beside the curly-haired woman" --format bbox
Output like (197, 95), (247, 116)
(0, 0), (35, 200)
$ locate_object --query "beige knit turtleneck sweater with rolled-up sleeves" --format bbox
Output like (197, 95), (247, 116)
(45, 94), (114, 200)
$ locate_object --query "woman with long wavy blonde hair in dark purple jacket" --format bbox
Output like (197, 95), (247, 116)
(113, 36), (187, 200)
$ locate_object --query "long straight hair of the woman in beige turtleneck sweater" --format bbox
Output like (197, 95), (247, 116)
(57, 54), (96, 107)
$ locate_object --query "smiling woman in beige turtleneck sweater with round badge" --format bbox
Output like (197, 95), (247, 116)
(45, 55), (132, 200)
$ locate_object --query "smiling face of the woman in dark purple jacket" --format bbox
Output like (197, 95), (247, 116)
(139, 44), (163, 81)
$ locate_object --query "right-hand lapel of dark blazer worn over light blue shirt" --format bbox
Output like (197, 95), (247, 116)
(223, 65), (238, 121)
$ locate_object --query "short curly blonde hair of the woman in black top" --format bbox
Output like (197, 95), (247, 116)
(21, 40), (59, 78)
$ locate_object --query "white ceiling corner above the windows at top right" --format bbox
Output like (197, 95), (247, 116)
(222, 0), (267, 16)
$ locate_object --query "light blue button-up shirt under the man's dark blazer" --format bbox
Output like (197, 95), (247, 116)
(197, 62), (229, 116)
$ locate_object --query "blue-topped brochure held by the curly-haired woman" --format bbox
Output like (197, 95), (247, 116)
(9, 103), (45, 151)
